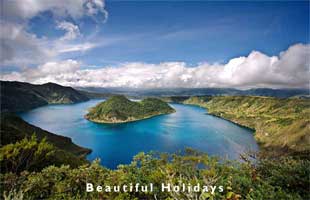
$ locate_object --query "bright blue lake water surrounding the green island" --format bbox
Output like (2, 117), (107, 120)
(20, 100), (258, 168)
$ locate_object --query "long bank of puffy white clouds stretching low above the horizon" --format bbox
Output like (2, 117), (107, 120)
(1, 44), (310, 88)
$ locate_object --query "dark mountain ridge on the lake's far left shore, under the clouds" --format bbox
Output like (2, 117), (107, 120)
(0, 81), (89, 112)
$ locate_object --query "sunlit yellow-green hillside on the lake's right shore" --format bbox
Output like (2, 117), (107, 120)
(204, 96), (310, 153)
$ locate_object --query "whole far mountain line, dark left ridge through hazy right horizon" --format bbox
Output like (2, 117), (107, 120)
(0, 81), (309, 112)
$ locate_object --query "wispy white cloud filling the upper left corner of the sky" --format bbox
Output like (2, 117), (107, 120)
(0, 0), (108, 67)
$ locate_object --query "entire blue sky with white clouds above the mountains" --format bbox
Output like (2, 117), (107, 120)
(0, 0), (310, 88)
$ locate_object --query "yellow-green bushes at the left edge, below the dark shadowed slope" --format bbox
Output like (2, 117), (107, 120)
(0, 135), (86, 174)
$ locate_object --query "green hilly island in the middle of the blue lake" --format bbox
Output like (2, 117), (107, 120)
(85, 95), (175, 123)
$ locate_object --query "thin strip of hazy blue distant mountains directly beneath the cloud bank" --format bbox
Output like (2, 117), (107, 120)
(76, 87), (309, 98)
